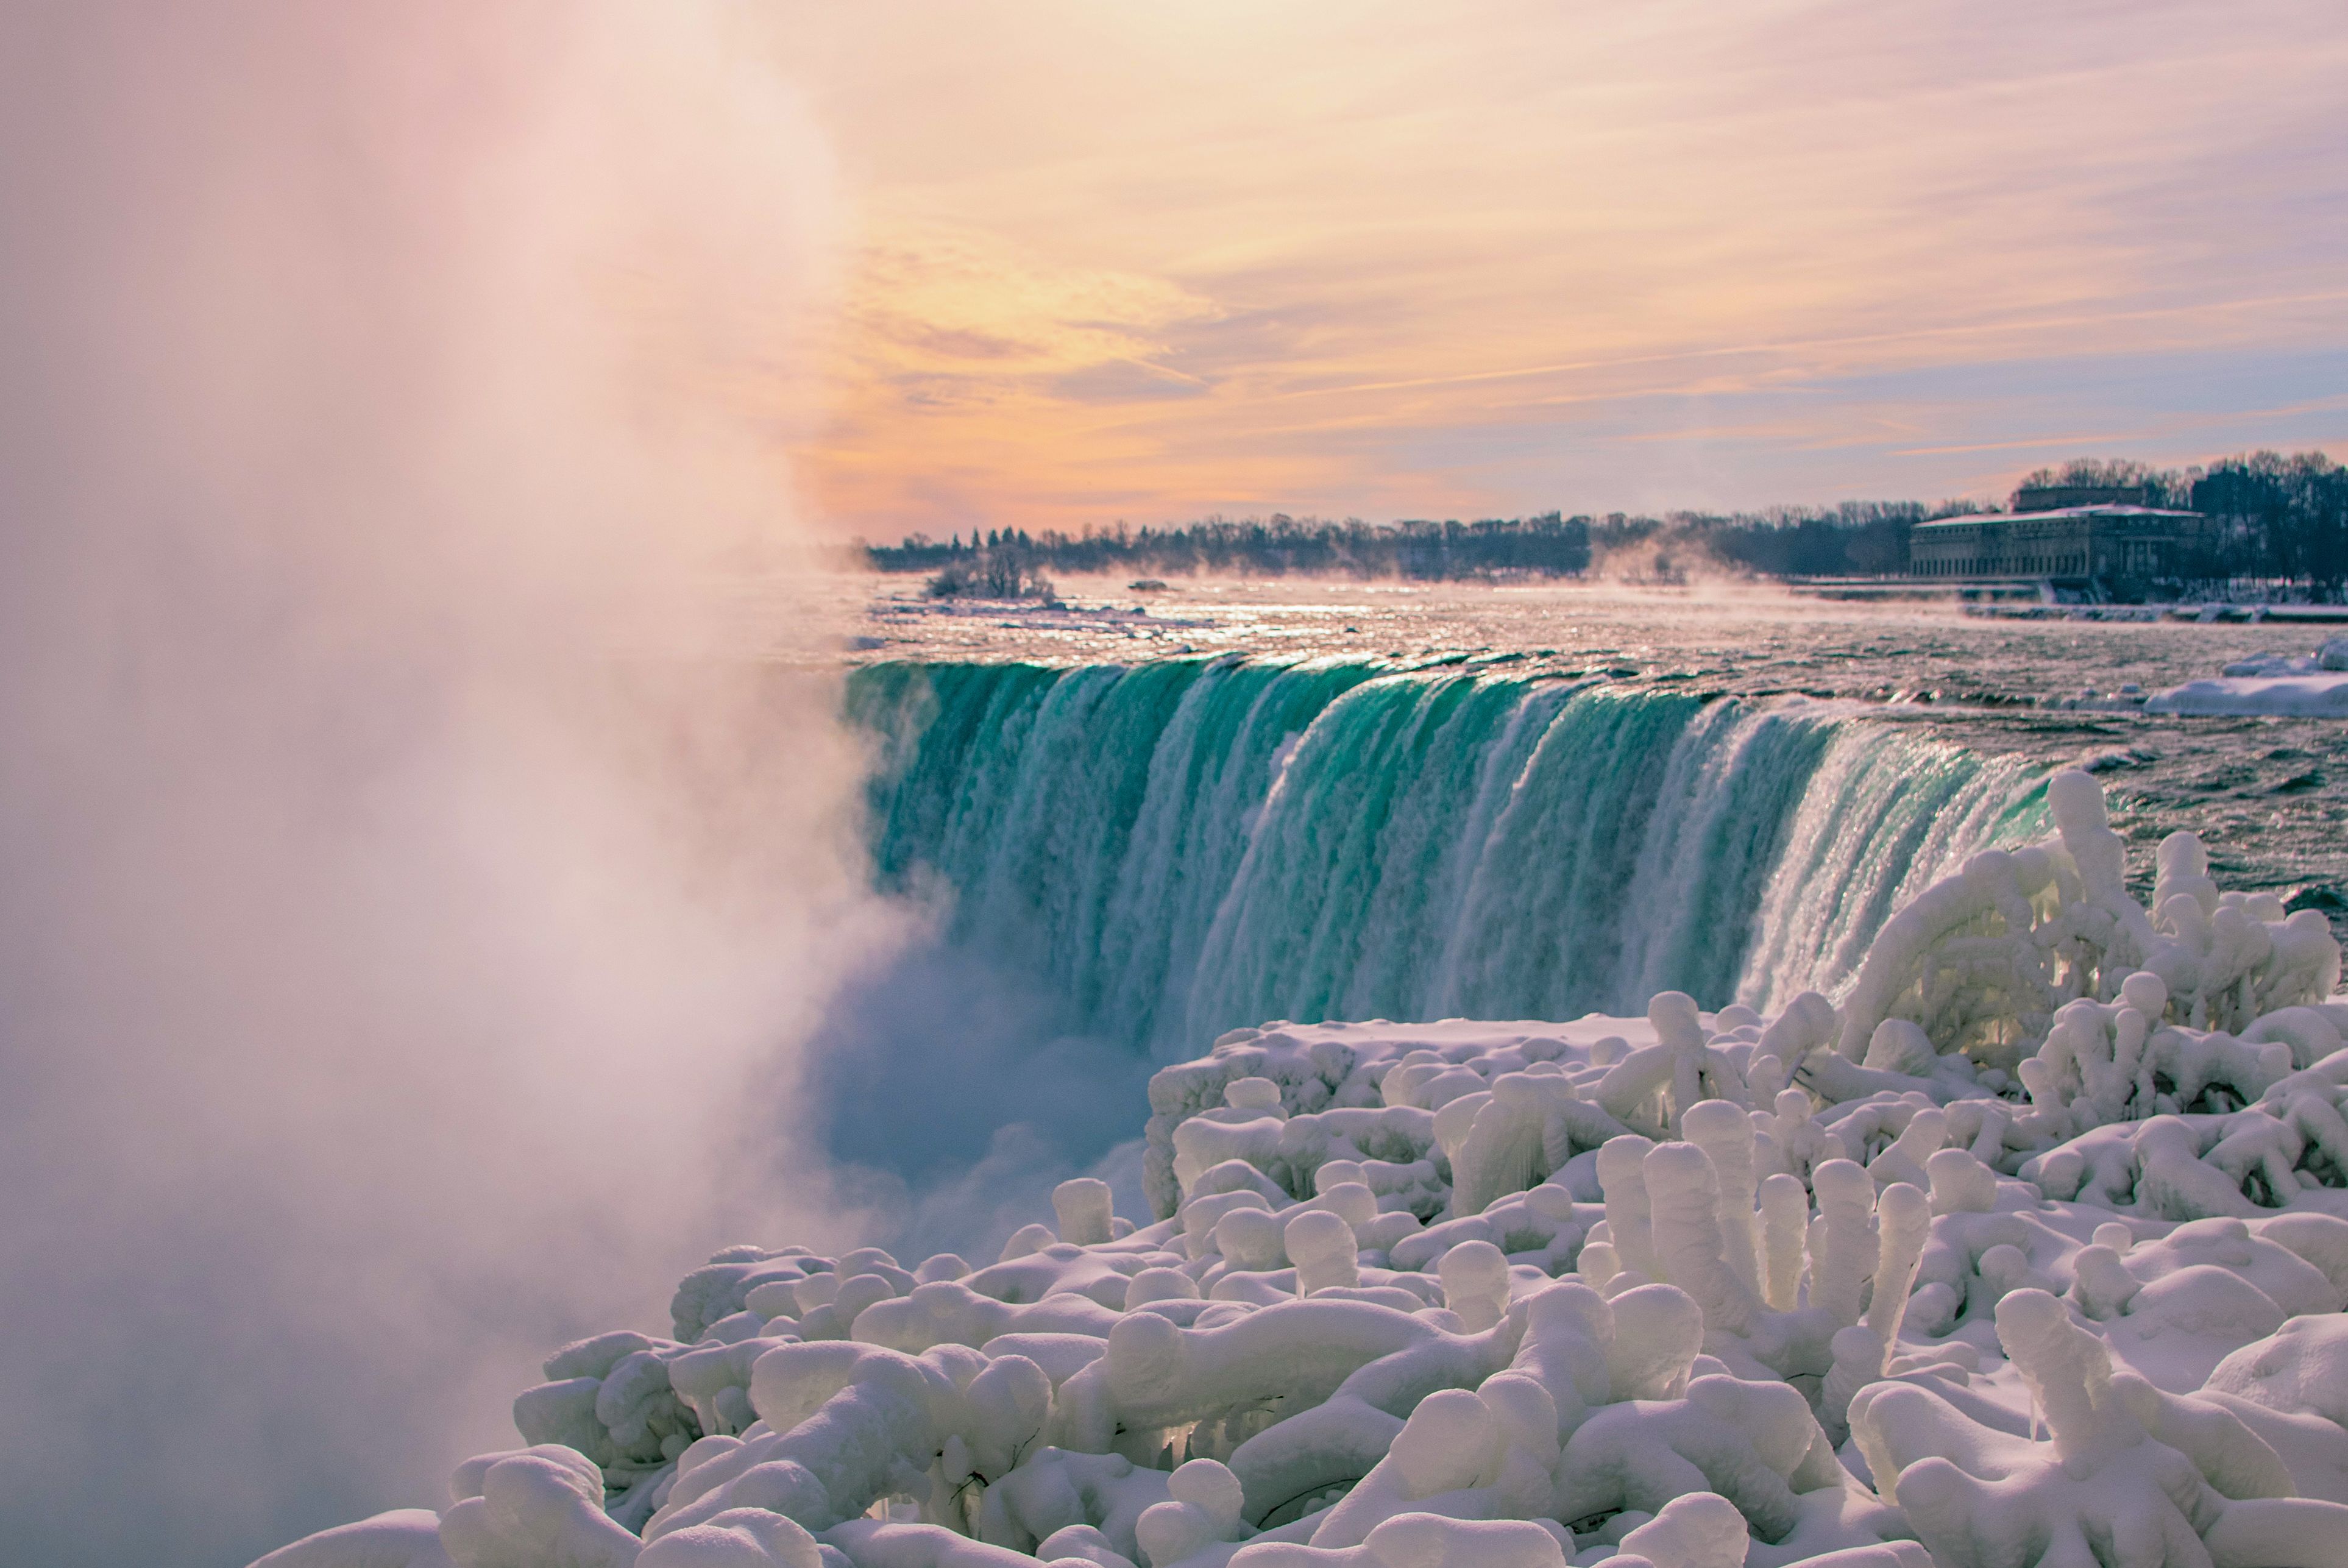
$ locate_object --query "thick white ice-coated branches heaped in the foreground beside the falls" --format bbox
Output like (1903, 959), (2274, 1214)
(263, 772), (2348, 1568)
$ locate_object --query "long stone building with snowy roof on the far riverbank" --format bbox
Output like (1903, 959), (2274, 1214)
(1909, 505), (2202, 596)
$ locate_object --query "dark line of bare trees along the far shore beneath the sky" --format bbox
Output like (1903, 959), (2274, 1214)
(867, 453), (2348, 596)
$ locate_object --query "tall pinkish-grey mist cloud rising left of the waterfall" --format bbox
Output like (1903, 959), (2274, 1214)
(0, 0), (890, 1563)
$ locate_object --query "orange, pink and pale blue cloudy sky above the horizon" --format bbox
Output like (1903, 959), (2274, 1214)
(770, 0), (2348, 540)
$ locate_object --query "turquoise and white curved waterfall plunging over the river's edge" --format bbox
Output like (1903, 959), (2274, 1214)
(848, 658), (2043, 1056)
